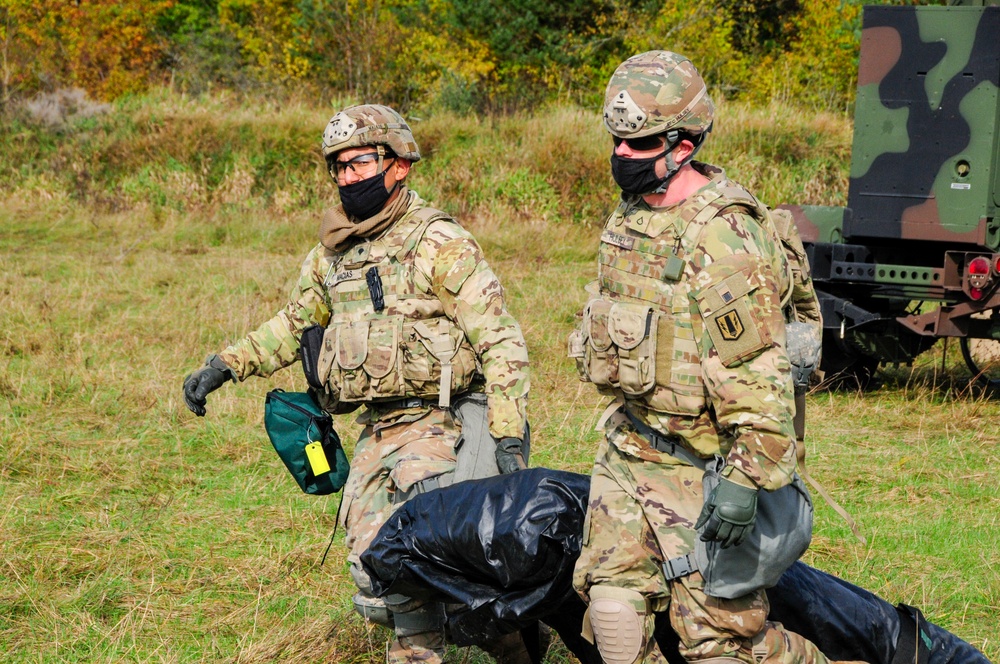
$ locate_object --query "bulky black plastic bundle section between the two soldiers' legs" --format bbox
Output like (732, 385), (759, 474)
(361, 468), (590, 645)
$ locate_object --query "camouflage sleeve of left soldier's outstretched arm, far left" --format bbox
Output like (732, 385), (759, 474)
(219, 245), (330, 380)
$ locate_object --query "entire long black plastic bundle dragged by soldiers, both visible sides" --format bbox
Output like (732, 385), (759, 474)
(361, 468), (988, 664)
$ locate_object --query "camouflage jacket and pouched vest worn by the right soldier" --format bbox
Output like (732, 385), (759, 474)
(570, 162), (795, 489)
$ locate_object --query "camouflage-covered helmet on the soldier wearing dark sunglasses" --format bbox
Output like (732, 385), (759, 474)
(604, 51), (715, 138)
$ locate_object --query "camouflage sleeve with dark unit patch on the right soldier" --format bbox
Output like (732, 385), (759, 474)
(691, 212), (796, 490)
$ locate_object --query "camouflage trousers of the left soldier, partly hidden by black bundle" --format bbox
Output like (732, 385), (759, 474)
(341, 409), (461, 664)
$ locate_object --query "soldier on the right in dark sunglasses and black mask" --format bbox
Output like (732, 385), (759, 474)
(570, 51), (848, 664)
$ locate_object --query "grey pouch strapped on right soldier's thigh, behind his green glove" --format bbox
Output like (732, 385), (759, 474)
(694, 456), (813, 599)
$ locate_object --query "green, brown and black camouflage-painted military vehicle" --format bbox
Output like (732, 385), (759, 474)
(779, 0), (1000, 387)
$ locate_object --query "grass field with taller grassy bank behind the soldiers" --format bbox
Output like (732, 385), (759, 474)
(0, 94), (1000, 664)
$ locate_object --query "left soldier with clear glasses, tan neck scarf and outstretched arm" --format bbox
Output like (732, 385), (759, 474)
(184, 105), (528, 664)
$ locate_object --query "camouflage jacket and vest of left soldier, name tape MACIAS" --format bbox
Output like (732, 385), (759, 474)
(219, 191), (529, 438)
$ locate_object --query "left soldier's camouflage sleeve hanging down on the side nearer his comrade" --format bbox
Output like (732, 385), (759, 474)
(416, 221), (529, 439)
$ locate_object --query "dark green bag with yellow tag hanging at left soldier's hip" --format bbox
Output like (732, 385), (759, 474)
(264, 389), (350, 496)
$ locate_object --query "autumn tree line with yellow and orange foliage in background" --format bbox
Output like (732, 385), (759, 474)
(0, 0), (914, 113)
